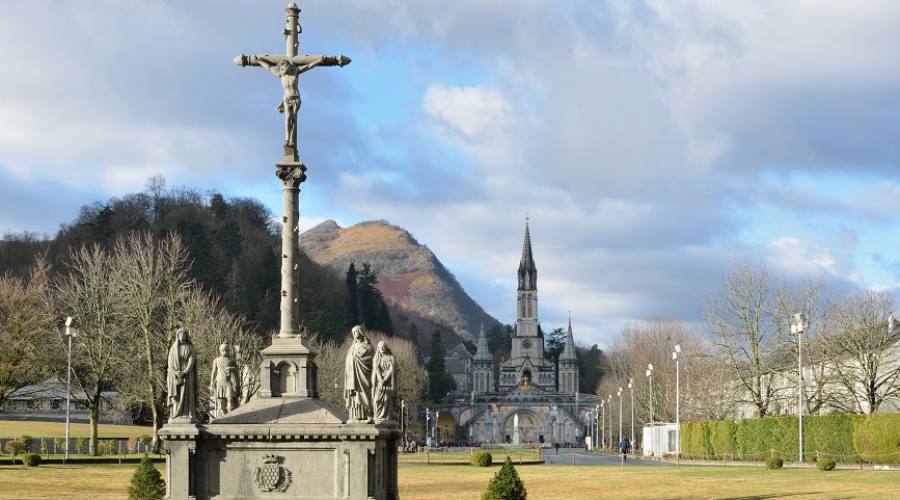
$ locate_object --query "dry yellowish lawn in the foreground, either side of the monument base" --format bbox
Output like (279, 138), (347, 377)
(0, 464), (900, 500)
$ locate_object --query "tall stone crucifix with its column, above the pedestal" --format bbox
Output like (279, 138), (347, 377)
(234, 3), (350, 338)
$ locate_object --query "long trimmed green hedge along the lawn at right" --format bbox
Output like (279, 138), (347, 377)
(681, 413), (900, 464)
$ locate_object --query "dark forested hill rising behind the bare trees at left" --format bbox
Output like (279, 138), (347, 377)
(0, 178), (346, 338)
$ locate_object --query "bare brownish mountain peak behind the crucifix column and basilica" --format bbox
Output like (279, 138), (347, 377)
(300, 220), (499, 341)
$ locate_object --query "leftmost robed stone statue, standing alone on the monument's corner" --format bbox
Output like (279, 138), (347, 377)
(166, 328), (197, 422)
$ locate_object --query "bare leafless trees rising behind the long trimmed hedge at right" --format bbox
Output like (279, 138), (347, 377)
(597, 263), (900, 444)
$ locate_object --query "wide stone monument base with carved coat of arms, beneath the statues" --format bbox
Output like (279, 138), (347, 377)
(159, 397), (400, 500)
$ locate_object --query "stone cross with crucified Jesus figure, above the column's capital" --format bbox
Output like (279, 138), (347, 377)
(234, 3), (350, 161)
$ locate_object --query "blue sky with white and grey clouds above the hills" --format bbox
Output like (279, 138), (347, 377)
(0, 0), (900, 343)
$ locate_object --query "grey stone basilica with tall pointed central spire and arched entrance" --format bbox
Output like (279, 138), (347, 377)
(436, 222), (599, 445)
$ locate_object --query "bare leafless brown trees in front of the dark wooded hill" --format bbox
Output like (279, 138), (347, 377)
(0, 232), (262, 453)
